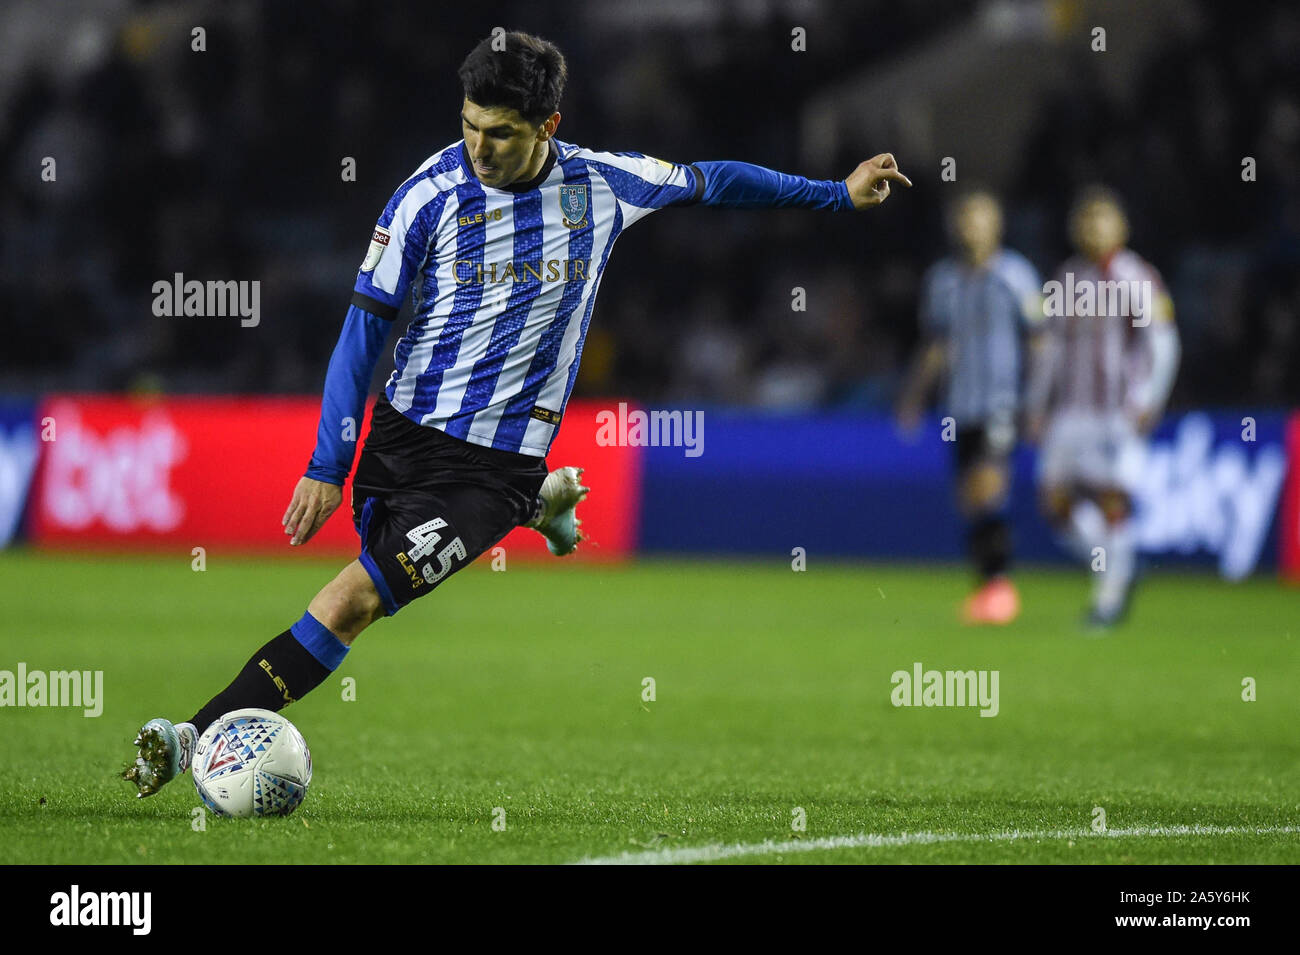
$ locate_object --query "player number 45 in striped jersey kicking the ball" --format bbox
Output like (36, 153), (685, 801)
(124, 32), (911, 796)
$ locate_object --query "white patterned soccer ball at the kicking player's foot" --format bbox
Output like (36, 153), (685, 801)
(191, 709), (312, 819)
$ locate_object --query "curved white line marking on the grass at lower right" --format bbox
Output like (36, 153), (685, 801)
(573, 825), (1300, 865)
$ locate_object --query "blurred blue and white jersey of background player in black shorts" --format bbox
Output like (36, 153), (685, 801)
(920, 248), (1043, 425)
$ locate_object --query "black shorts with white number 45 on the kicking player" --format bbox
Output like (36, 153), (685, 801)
(352, 396), (546, 616)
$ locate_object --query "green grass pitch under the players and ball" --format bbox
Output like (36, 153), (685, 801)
(0, 552), (1300, 864)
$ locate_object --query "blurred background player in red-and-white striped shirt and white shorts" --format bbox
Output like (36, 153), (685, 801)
(1028, 187), (1179, 629)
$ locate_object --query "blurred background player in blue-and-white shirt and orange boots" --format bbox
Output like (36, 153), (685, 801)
(898, 191), (1043, 624)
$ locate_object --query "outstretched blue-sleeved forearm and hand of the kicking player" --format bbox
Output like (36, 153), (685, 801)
(690, 152), (911, 210)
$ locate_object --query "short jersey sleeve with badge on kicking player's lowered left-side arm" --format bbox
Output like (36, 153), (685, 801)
(352, 175), (446, 320)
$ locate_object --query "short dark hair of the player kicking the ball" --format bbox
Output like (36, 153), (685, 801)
(459, 31), (568, 123)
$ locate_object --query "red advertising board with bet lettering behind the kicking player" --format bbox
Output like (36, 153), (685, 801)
(29, 395), (641, 560)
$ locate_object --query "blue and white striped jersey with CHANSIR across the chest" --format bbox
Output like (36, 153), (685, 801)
(352, 139), (705, 456)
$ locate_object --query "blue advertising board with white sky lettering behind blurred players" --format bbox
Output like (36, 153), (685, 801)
(640, 409), (1286, 578)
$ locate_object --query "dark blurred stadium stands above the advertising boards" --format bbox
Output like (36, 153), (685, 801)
(0, 0), (1300, 409)
